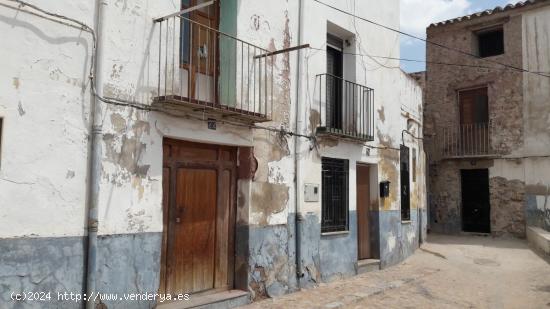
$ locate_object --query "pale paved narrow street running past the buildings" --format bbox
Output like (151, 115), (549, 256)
(245, 235), (550, 309)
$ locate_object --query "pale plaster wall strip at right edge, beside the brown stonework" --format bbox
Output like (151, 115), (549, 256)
(523, 6), (550, 231)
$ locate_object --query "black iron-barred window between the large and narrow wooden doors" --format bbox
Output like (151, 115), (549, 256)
(321, 158), (349, 233)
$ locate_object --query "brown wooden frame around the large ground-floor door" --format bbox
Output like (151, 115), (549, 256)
(159, 137), (238, 295)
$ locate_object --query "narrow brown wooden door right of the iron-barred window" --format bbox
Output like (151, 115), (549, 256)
(356, 165), (372, 260)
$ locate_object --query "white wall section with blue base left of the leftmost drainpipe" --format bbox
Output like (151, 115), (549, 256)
(0, 1), (94, 308)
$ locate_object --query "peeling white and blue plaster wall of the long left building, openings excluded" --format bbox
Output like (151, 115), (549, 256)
(0, 0), (425, 308)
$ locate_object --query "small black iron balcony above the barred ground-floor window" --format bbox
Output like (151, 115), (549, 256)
(316, 74), (374, 141)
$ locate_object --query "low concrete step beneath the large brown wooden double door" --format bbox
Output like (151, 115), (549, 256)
(156, 290), (250, 309)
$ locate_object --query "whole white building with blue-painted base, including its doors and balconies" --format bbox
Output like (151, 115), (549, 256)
(0, 0), (427, 308)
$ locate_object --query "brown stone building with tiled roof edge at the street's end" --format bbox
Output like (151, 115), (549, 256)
(424, 0), (550, 237)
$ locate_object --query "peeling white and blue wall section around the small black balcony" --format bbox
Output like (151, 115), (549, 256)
(299, 1), (426, 280)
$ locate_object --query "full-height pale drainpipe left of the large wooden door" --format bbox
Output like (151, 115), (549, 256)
(86, 0), (107, 309)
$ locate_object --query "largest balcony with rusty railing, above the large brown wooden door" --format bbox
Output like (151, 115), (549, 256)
(153, 14), (274, 124)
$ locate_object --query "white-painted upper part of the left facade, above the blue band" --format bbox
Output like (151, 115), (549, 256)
(0, 0), (426, 306)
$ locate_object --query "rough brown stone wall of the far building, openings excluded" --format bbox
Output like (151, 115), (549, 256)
(424, 8), (525, 237)
